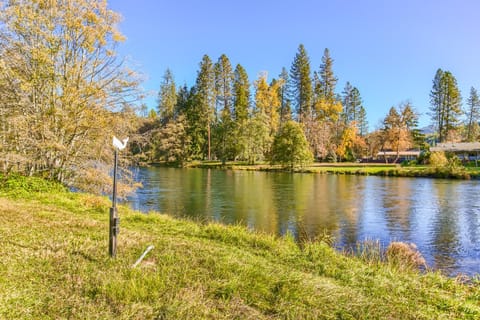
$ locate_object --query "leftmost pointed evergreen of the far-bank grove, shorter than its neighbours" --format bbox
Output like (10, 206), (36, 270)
(157, 69), (177, 124)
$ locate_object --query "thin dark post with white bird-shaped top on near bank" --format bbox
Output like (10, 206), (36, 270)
(108, 137), (128, 258)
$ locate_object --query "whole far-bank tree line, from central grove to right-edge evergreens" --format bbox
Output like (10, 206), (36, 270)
(132, 44), (480, 165)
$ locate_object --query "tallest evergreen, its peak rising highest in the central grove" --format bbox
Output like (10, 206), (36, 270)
(289, 44), (313, 122)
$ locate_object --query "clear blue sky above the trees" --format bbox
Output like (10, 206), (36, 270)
(110, 0), (480, 129)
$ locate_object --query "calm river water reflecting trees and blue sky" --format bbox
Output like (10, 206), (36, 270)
(129, 168), (480, 275)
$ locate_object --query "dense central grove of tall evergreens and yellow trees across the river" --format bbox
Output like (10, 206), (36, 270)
(132, 45), (374, 164)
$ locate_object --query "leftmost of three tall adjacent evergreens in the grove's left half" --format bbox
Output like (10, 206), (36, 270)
(195, 55), (215, 160)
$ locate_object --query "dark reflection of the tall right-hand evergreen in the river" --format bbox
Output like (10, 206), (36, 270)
(432, 183), (460, 271)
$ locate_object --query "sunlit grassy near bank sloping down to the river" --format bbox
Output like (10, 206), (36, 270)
(0, 179), (480, 319)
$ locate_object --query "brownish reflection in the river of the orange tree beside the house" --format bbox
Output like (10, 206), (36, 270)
(382, 178), (413, 241)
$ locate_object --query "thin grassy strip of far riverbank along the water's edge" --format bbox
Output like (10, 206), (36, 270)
(181, 161), (480, 179)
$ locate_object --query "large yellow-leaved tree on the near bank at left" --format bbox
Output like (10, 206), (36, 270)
(0, 0), (139, 191)
